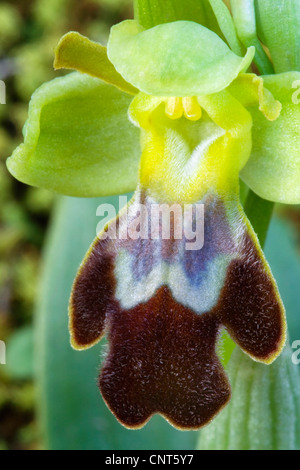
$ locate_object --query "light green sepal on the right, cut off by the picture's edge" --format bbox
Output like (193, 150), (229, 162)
(241, 72), (300, 204)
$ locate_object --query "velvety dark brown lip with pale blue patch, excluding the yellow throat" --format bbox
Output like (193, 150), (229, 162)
(70, 185), (285, 429)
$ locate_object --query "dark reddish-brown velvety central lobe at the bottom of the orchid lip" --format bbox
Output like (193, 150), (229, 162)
(99, 287), (230, 429)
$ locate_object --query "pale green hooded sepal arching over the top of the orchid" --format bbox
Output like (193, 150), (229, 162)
(108, 20), (254, 96)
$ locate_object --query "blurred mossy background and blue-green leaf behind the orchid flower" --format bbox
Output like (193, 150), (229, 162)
(0, 0), (300, 450)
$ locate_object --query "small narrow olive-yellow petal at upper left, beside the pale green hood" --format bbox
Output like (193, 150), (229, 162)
(54, 31), (138, 95)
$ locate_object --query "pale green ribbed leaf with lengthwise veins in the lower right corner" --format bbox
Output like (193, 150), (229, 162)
(198, 347), (300, 450)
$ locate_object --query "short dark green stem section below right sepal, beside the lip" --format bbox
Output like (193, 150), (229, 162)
(244, 189), (274, 247)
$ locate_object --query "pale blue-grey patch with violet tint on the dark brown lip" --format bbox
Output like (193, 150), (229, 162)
(115, 189), (238, 314)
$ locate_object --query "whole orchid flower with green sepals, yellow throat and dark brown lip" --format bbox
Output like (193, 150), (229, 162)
(8, 1), (300, 429)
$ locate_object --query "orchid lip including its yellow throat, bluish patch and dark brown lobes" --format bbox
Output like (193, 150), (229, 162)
(70, 92), (286, 429)
